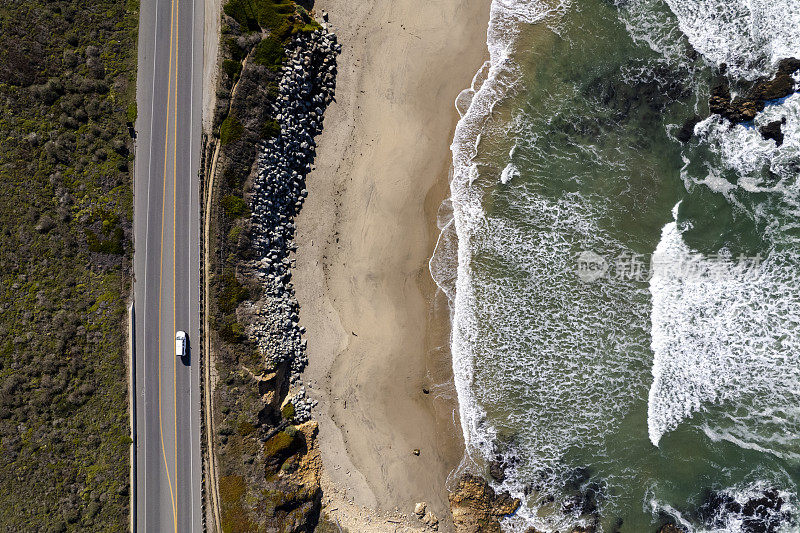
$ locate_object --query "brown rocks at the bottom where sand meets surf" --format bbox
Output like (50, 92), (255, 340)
(449, 474), (520, 533)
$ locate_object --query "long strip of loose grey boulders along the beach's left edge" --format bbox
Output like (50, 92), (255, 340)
(248, 28), (341, 388)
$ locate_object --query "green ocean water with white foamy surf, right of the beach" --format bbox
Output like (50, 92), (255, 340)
(431, 0), (800, 533)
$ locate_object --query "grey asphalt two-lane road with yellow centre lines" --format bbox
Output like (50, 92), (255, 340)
(134, 0), (204, 532)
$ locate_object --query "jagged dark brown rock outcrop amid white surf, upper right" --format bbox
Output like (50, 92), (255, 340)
(708, 57), (800, 124)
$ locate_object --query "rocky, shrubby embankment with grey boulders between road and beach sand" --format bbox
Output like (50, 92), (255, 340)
(204, 0), (339, 531)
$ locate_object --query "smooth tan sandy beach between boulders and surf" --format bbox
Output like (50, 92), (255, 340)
(294, 0), (490, 531)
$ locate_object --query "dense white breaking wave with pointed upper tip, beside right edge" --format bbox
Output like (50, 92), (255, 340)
(647, 202), (800, 450)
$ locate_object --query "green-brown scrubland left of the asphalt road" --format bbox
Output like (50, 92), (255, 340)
(0, 0), (139, 531)
